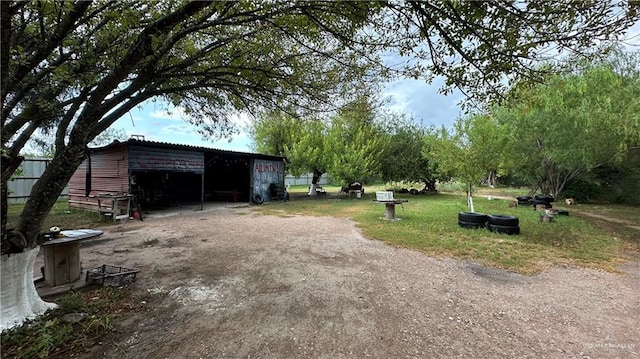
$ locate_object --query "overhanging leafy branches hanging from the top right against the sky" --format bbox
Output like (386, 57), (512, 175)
(376, 0), (640, 104)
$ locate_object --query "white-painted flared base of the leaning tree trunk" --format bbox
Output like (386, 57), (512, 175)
(0, 248), (57, 331)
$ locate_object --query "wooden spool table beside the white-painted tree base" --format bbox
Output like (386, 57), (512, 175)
(41, 230), (103, 287)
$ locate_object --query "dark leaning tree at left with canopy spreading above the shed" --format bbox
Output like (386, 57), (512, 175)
(1, 1), (375, 252)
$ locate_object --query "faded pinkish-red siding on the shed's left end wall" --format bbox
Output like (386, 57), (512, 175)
(69, 145), (129, 210)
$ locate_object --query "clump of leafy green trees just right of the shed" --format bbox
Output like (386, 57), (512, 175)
(250, 96), (387, 196)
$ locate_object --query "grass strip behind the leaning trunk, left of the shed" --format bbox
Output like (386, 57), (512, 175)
(7, 200), (114, 231)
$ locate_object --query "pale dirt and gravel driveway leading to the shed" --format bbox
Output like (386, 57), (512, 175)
(72, 208), (640, 358)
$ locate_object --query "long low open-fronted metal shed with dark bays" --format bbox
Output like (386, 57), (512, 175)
(69, 139), (285, 214)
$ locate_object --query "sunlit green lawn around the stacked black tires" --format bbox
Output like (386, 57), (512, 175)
(256, 191), (640, 273)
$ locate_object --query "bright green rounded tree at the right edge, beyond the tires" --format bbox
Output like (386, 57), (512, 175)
(493, 52), (640, 197)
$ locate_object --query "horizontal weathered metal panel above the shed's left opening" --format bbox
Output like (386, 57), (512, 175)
(129, 146), (204, 173)
